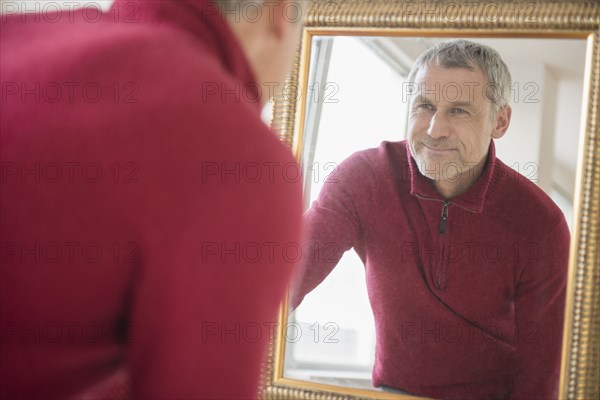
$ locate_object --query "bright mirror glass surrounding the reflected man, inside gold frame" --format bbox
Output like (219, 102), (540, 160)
(283, 36), (586, 396)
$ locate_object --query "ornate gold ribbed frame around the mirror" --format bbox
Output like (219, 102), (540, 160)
(260, 0), (600, 400)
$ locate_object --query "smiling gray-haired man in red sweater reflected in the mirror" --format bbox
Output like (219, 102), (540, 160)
(292, 40), (569, 399)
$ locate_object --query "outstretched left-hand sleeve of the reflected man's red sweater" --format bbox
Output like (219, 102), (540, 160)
(290, 152), (374, 309)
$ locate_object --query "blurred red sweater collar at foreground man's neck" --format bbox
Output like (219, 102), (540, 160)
(111, 0), (261, 112)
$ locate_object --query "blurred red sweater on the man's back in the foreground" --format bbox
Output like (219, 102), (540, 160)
(0, 0), (302, 399)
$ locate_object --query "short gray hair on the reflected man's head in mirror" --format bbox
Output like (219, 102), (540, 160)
(408, 39), (512, 116)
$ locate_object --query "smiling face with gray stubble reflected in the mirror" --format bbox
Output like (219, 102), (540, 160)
(408, 65), (504, 181)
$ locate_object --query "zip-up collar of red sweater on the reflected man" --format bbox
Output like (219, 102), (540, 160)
(405, 139), (497, 213)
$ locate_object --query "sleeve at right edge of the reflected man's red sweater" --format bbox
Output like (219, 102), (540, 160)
(510, 216), (570, 400)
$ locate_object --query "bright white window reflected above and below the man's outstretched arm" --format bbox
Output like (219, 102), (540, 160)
(286, 37), (408, 387)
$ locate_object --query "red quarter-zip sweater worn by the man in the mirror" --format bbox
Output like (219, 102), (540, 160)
(292, 142), (569, 400)
